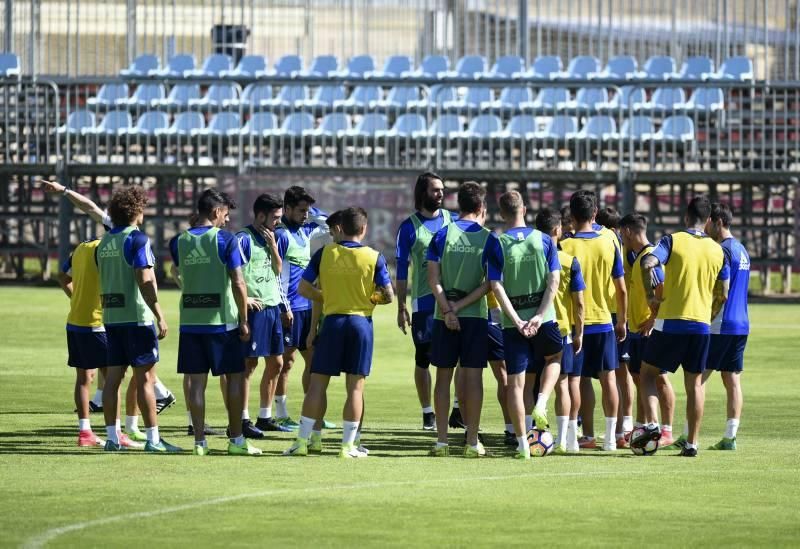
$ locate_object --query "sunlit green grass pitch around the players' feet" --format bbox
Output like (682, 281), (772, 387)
(0, 287), (800, 547)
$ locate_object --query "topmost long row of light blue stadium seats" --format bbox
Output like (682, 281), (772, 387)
(115, 53), (753, 81)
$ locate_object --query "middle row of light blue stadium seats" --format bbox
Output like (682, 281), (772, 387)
(86, 82), (725, 114)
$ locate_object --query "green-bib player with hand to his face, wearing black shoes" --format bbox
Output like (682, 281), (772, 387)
(236, 194), (288, 438)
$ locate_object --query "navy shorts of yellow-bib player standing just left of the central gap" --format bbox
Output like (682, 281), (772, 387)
(311, 315), (373, 376)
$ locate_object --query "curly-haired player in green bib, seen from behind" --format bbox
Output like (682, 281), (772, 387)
(95, 186), (180, 452)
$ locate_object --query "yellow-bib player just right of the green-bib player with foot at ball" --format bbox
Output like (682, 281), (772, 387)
(536, 208), (586, 453)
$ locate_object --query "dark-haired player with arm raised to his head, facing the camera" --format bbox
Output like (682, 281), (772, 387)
(268, 186), (334, 430)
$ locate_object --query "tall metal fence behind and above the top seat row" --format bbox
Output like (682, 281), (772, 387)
(0, 0), (800, 80)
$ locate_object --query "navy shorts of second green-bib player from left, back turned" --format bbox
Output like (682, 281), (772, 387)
(178, 328), (244, 376)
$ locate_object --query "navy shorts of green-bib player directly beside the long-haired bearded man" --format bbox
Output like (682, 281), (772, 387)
(431, 318), (489, 368)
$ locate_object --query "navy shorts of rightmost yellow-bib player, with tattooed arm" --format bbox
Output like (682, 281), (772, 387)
(644, 330), (711, 374)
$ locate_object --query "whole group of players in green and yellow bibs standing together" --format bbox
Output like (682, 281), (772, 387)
(42, 172), (750, 459)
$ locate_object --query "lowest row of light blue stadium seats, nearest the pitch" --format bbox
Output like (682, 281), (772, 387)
(58, 110), (695, 143)
